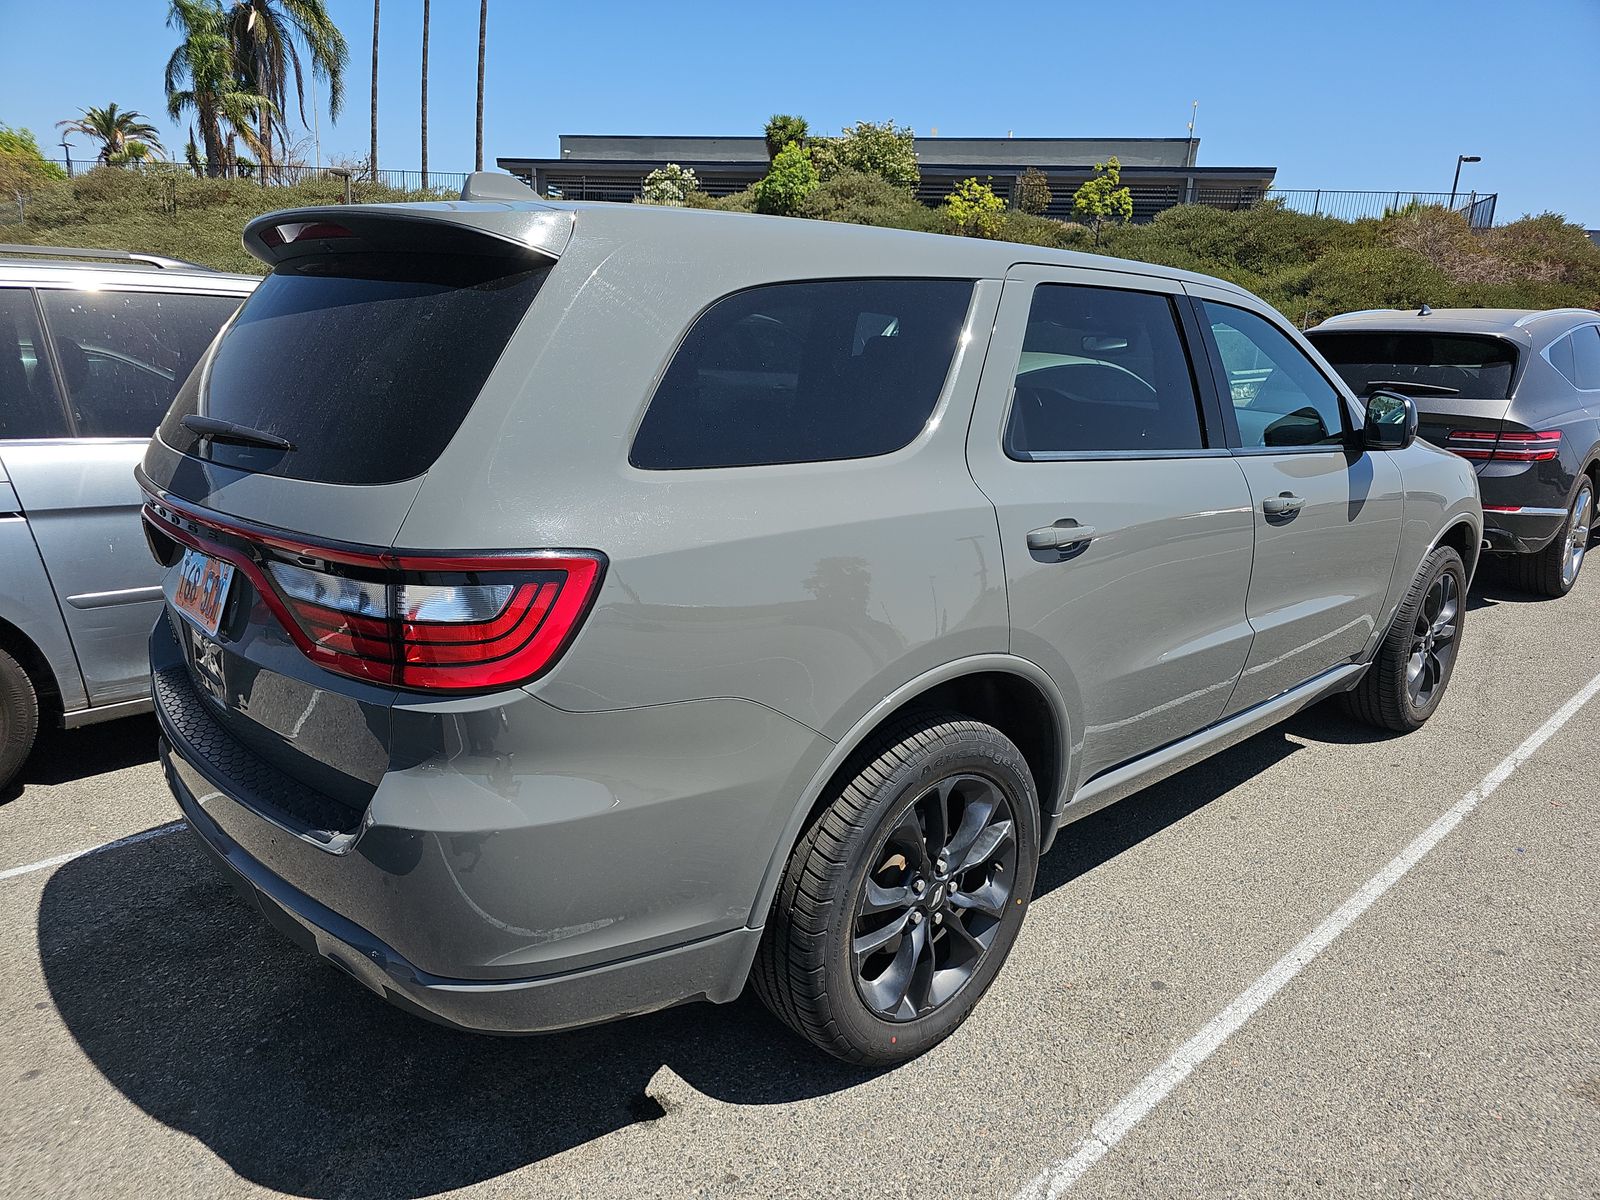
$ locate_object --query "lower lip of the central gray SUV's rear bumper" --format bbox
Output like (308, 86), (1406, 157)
(162, 738), (762, 1034)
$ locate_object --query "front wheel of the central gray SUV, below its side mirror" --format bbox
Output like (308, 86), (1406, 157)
(1342, 546), (1467, 733)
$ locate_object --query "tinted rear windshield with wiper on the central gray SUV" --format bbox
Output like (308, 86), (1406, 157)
(160, 254), (549, 485)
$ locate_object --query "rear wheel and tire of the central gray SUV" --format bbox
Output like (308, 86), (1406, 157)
(752, 714), (1038, 1066)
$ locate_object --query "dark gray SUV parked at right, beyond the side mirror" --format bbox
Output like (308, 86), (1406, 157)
(1306, 306), (1600, 597)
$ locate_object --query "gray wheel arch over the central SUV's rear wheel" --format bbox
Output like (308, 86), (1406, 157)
(749, 654), (1072, 928)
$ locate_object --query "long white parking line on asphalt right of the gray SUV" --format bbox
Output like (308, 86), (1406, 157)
(1018, 675), (1600, 1200)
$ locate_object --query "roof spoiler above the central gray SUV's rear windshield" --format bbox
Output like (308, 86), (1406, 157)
(243, 206), (573, 273)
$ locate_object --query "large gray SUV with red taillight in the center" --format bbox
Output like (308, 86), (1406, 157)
(141, 192), (1482, 1062)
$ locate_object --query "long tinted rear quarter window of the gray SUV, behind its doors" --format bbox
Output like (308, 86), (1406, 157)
(629, 280), (973, 470)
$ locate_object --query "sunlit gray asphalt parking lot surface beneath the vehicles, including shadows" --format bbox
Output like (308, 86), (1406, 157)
(0, 565), (1600, 1198)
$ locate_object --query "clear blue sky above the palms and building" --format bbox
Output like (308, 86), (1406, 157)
(0, 0), (1600, 227)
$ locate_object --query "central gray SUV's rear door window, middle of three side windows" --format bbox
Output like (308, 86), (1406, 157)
(1006, 283), (1205, 459)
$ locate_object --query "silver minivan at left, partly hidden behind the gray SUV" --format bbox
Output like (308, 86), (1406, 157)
(0, 246), (256, 789)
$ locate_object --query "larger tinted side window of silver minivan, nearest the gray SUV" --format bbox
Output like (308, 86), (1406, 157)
(40, 288), (243, 437)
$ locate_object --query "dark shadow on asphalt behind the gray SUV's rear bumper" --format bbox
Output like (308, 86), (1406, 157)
(38, 832), (874, 1200)
